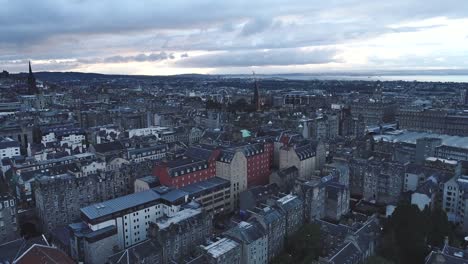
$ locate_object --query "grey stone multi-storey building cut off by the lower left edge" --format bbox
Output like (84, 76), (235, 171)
(0, 195), (19, 244)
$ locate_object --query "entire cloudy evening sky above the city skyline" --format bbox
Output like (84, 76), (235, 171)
(0, 0), (468, 75)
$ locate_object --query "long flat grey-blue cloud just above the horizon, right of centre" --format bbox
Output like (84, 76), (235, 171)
(176, 49), (337, 68)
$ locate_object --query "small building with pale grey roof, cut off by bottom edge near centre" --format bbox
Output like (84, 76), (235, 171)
(200, 237), (242, 264)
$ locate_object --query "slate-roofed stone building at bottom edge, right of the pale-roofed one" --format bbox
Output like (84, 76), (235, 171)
(224, 221), (268, 264)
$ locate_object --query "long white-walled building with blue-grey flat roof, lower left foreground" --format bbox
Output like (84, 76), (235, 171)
(68, 189), (186, 263)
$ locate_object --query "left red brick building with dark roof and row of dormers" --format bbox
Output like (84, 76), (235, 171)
(153, 147), (219, 188)
